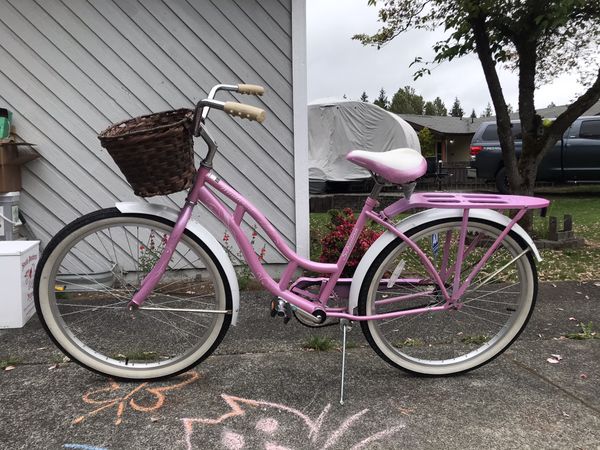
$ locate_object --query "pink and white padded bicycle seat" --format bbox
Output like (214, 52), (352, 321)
(346, 148), (427, 184)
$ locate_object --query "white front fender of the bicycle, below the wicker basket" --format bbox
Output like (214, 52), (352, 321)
(115, 202), (240, 325)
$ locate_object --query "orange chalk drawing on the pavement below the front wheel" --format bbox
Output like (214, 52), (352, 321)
(72, 371), (200, 425)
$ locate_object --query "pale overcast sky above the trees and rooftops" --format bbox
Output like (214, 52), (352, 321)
(307, 0), (583, 116)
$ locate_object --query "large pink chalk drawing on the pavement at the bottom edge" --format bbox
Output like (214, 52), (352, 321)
(181, 394), (405, 450)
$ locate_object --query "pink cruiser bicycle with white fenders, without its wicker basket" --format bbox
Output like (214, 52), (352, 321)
(35, 85), (548, 390)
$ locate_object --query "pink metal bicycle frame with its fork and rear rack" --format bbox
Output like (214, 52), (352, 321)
(129, 164), (549, 321)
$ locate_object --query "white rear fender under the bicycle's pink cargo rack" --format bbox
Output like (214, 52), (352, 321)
(348, 209), (542, 313)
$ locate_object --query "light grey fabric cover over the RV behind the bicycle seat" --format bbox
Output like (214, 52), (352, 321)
(308, 101), (421, 181)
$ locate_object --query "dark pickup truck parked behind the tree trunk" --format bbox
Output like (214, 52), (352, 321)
(471, 116), (600, 193)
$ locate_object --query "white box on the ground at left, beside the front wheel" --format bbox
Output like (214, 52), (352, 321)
(0, 241), (39, 328)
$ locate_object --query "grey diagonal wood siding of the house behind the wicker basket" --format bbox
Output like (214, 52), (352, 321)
(0, 0), (305, 263)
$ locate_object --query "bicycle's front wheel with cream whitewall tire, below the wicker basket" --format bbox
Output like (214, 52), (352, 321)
(35, 208), (232, 380)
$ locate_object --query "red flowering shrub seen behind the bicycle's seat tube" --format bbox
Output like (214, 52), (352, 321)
(319, 208), (381, 278)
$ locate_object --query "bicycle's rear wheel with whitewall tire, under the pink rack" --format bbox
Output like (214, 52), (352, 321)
(358, 218), (537, 375)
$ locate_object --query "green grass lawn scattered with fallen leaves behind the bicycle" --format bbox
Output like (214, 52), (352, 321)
(310, 192), (600, 281)
